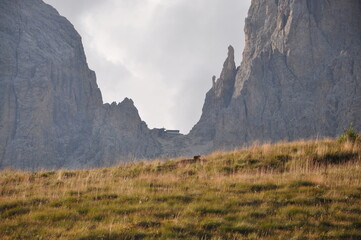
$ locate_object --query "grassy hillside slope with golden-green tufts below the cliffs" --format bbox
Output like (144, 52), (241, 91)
(0, 140), (361, 240)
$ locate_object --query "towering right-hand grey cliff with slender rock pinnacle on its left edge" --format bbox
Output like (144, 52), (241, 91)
(190, 0), (361, 149)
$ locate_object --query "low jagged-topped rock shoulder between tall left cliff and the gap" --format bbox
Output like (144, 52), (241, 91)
(90, 98), (162, 166)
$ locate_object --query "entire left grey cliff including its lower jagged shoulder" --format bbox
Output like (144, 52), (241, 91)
(0, 0), (160, 170)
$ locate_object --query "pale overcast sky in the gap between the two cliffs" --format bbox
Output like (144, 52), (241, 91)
(45, 0), (250, 133)
